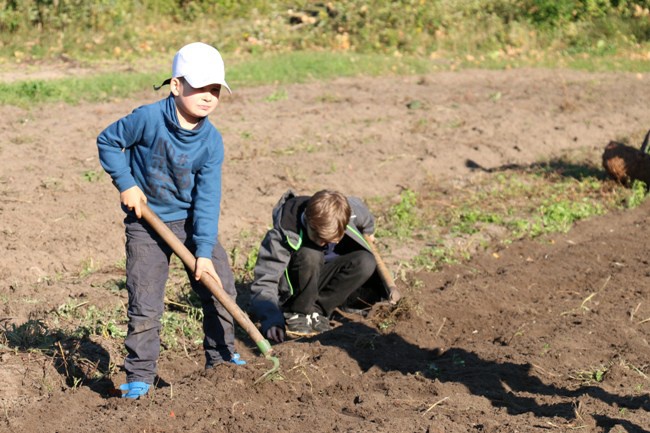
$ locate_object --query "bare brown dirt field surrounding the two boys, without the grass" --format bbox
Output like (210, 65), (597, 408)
(0, 70), (650, 433)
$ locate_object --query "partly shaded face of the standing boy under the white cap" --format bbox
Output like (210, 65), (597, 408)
(170, 78), (221, 129)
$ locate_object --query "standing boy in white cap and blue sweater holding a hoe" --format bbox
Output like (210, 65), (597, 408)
(97, 42), (245, 398)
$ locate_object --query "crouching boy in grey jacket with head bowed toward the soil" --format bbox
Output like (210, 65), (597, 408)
(250, 190), (385, 342)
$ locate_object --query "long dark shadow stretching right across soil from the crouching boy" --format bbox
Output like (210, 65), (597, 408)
(300, 321), (650, 433)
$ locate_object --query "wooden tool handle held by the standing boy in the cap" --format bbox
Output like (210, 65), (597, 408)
(140, 202), (272, 355)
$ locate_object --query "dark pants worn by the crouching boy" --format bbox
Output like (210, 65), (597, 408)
(283, 236), (377, 317)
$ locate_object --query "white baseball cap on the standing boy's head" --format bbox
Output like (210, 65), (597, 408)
(172, 42), (232, 93)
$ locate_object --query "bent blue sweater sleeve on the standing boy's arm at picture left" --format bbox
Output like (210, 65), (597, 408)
(97, 109), (144, 192)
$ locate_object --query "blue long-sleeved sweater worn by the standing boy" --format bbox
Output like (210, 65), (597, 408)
(97, 95), (224, 257)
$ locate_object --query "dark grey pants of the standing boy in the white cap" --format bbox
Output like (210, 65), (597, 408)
(124, 217), (237, 384)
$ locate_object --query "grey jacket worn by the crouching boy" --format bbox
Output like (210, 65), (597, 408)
(250, 190), (375, 335)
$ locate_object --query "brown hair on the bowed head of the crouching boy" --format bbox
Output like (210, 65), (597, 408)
(305, 189), (352, 242)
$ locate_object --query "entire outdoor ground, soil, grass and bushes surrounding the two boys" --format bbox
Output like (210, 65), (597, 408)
(0, 0), (650, 433)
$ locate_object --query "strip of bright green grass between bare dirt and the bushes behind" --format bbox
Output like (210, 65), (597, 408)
(6, 45), (650, 108)
